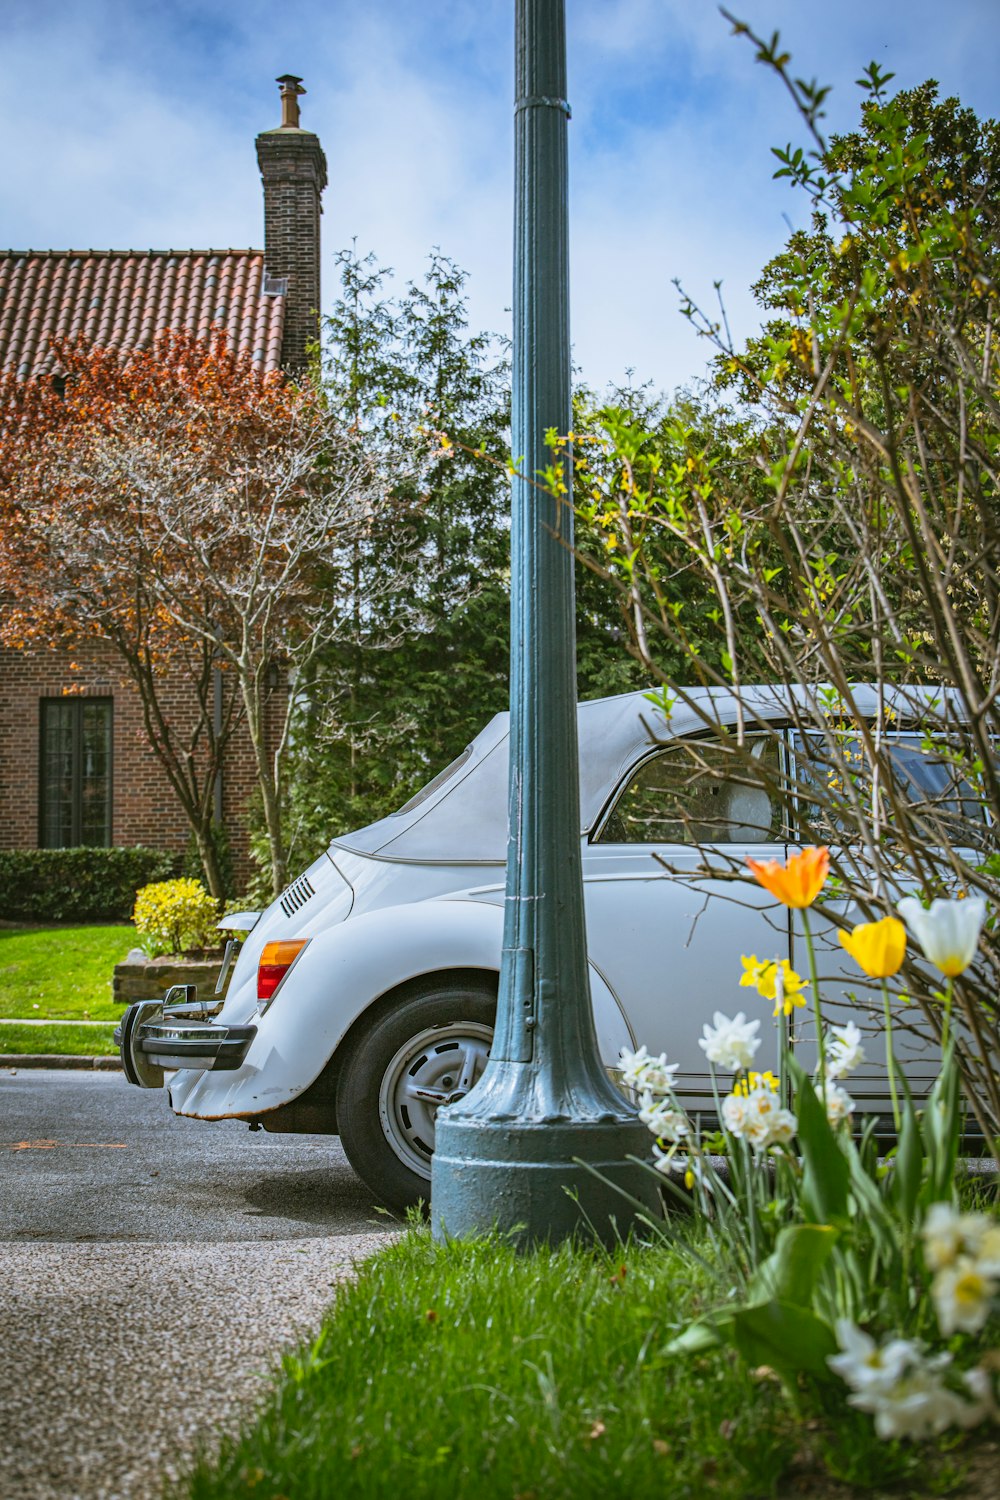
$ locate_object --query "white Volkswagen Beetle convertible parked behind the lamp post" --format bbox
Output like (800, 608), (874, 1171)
(117, 690), (959, 1208)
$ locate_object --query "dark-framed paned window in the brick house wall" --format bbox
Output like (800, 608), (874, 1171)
(39, 698), (112, 849)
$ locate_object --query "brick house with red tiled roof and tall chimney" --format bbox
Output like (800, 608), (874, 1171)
(0, 74), (327, 884)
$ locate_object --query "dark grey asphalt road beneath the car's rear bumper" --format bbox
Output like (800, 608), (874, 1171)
(0, 1068), (385, 1244)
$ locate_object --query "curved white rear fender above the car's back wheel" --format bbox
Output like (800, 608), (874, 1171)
(168, 899), (633, 1119)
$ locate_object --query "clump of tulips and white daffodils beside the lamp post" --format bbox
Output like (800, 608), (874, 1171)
(622, 849), (1000, 1440)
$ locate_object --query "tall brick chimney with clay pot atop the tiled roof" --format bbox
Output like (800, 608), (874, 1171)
(256, 74), (327, 375)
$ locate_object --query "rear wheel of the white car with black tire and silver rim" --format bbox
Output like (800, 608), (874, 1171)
(337, 977), (496, 1211)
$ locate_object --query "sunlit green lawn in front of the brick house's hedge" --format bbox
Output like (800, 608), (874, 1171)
(0, 923), (135, 1026)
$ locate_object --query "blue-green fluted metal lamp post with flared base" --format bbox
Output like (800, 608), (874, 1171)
(430, 0), (657, 1244)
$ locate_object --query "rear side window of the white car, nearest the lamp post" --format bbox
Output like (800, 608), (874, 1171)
(595, 735), (781, 845)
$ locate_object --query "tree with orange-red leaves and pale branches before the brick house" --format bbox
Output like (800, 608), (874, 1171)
(0, 333), (407, 896)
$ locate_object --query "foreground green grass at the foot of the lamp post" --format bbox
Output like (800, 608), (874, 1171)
(180, 1230), (983, 1500)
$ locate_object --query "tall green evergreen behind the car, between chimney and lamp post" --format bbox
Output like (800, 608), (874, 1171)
(281, 249), (646, 864)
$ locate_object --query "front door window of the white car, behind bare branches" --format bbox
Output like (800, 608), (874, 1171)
(790, 731), (987, 842)
